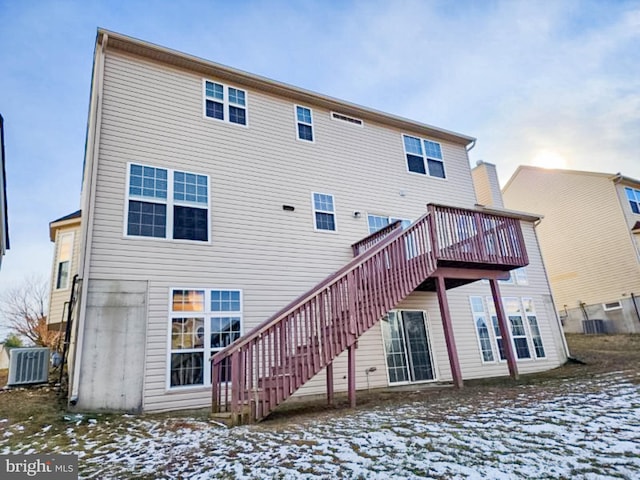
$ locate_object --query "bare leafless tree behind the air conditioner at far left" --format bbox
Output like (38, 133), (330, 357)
(0, 276), (59, 347)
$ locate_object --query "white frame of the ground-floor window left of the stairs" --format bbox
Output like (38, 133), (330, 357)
(165, 287), (245, 392)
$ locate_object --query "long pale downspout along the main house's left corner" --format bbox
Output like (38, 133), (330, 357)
(69, 32), (109, 405)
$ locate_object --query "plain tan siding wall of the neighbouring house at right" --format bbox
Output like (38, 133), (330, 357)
(504, 167), (640, 309)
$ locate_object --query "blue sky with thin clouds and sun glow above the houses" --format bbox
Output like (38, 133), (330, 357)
(0, 0), (640, 330)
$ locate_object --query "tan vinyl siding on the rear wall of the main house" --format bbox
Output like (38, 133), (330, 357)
(82, 51), (568, 410)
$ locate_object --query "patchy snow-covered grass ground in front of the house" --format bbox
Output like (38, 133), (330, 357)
(0, 372), (640, 479)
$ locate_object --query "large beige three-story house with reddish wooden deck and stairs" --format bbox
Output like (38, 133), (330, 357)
(62, 30), (568, 419)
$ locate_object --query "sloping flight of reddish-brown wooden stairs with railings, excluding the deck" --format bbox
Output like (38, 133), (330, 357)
(212, 214), (436, 421)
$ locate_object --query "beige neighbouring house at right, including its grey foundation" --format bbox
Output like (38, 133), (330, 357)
(503, 166), (640, 333)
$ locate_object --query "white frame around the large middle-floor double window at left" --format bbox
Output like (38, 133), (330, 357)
(123, 162), (211, 245)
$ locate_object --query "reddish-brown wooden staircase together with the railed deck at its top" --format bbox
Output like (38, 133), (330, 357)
(211, 204), (528, 424)
